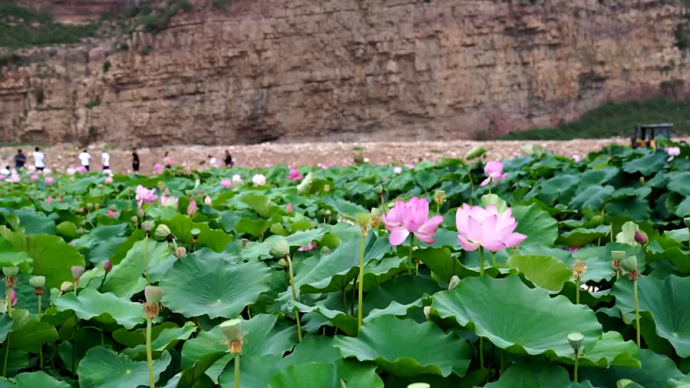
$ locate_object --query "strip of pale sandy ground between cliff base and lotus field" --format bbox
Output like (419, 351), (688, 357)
(0, 138), (630, 174)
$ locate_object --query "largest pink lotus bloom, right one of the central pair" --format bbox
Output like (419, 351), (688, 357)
(455, 204), (527, 252)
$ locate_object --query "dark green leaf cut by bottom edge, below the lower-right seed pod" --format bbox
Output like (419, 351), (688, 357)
(485, 363), (593, 388)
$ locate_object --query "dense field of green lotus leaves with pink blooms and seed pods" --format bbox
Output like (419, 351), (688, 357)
(0, 144), (690, 388)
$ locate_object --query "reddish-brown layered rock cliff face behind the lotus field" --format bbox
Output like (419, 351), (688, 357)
(0, 0), (690, 146)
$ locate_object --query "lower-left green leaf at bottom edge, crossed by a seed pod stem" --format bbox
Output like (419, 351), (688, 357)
(77, 346), (172, 388)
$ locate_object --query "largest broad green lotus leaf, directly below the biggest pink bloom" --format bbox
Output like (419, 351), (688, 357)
(432, 276), (603, 357)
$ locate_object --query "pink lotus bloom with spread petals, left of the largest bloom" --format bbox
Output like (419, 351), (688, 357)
(381, 197), (443, 245)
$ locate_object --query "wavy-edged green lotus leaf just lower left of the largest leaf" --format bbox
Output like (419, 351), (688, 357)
(334, 315), (471, 377)
